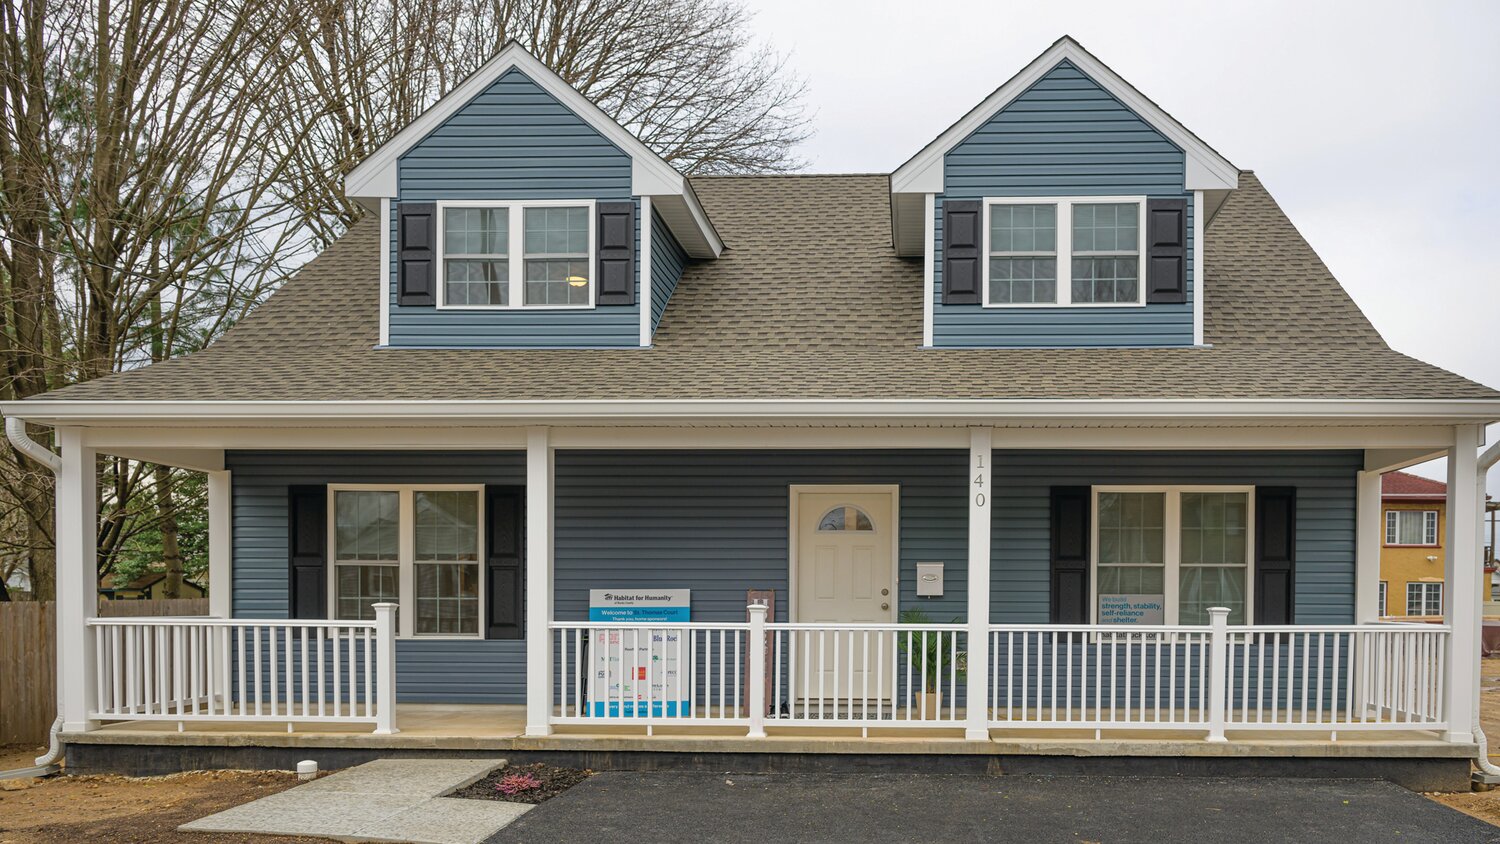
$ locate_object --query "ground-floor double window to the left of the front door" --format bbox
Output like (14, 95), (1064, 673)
(329, 484), (485, 639)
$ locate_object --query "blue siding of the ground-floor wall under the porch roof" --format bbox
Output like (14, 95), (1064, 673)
(227, 450), (1361, 703)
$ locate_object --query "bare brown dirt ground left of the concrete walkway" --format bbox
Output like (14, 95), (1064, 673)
(0, 767), (330, 844)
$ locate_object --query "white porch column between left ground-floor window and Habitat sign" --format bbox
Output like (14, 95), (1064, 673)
(527, 427), (552, 736)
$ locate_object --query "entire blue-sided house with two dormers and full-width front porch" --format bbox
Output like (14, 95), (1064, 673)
(3, 39), (1500, 787)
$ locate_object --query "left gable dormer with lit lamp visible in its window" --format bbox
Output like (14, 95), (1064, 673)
(345, 42), (723, 348)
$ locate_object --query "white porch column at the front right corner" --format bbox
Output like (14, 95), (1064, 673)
(1443, 424), (1484, 742)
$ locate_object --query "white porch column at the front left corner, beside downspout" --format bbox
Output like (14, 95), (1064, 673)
(56, 427), (99, 730)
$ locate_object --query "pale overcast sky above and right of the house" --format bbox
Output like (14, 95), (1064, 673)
(746, 0), (1500, 495)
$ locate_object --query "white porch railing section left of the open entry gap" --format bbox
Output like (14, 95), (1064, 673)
(89, 604), (396, 733)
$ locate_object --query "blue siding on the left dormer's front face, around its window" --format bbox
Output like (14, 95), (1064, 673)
(389, 69), (641, 348)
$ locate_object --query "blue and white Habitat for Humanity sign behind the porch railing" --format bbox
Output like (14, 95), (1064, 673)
(588, 589), (693, 718)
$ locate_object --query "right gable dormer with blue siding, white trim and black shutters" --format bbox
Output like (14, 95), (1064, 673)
(891, 37), (1239, 348)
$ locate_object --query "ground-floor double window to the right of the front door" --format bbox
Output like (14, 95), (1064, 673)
(1091, 486), (1256, 624)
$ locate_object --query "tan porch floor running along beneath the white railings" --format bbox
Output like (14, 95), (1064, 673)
(63, 703), (1475, 759)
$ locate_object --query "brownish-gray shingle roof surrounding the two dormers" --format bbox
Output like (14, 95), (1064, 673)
(32, 172), (1500, 402)
